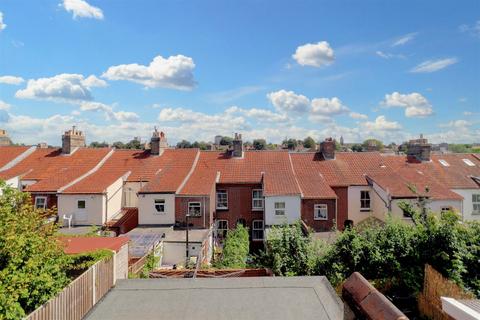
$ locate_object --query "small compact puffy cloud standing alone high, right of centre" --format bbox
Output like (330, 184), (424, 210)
(292, 41), (335, 67)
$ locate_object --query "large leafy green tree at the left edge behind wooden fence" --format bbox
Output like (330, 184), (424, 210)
(0, 182), (69, 319)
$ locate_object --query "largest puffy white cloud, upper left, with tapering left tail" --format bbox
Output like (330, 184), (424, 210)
(102, 55), (196, 90)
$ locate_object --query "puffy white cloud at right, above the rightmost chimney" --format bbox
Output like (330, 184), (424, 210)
(382, 92), (433, 118)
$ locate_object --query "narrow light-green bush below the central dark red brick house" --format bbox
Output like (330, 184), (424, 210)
(215, 224), (249, 268)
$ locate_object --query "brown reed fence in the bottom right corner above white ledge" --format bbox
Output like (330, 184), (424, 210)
(418, 264), (474, 320)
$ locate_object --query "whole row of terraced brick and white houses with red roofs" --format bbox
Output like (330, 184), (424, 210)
(0, 128), (480, 244)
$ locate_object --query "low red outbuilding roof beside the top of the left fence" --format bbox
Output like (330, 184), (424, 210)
(59, 236), (130, 254)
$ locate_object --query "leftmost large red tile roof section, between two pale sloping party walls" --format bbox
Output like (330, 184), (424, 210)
(0, 148), (111, 192)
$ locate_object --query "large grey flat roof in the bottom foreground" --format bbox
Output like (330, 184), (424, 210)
(85, 277), (344, 320)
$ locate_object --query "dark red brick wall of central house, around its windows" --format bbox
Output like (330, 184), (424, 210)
(215, 184), (263, 238)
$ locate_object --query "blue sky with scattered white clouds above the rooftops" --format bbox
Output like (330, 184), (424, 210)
(0, 0), (480, 144)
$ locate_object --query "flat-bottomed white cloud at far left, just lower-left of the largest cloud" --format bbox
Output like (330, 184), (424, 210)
(15, 73), (106, 103)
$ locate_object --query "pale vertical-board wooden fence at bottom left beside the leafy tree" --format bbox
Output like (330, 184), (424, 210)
(25, 257), (115, 320)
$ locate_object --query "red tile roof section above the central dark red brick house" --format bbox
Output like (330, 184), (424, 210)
(180, 151), (301, 196)
